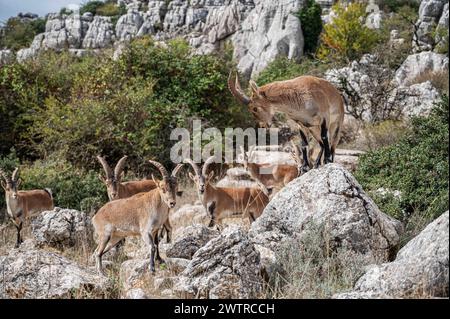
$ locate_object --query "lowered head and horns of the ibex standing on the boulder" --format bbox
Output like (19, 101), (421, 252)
(228, 72), (274, 127)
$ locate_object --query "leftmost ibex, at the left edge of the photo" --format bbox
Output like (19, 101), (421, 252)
(0, 168), (54, 247)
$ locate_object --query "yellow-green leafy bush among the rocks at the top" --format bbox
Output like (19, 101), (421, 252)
(318, 2), (380, 63)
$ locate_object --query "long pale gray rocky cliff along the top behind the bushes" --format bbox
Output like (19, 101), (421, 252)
(13, 0), (303, 76)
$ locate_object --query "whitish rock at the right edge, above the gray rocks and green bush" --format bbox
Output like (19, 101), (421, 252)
(395, 52), (448, 86)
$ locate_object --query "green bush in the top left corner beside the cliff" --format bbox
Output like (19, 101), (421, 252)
(0, 17), (45, 51)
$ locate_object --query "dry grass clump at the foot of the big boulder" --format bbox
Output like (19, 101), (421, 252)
(262, 228), (370, 299)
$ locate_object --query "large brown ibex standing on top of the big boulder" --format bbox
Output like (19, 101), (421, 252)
(228, 72), (344, 172)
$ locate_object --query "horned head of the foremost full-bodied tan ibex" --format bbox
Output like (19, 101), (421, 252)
(149, 160), (183, 208)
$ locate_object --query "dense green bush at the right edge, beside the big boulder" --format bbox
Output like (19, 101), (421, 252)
(355, 96), (449, 228)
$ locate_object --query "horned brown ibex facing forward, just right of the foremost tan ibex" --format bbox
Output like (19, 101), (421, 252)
(185, 156), (269, 227)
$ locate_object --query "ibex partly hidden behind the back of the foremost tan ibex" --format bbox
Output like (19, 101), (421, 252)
(97, 156), (156, 200)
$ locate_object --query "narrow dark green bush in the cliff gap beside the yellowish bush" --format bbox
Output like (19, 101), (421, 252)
(298, 0), (322, 53)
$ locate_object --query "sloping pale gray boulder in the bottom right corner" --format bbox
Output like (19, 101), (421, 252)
(334, 211), (449, 299)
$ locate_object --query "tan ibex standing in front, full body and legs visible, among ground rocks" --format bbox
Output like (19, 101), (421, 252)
(92, 161), (183, 274)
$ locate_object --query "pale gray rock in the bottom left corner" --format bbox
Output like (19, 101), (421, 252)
(0, 242), (109, 299)
